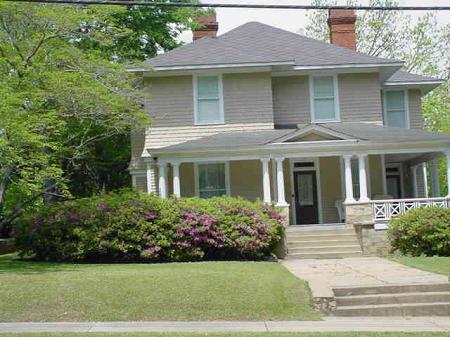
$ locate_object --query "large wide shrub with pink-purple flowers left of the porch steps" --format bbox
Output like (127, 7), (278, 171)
(14, 190), (284, 262)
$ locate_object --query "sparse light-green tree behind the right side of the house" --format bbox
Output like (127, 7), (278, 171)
(305, 0), (450, 195)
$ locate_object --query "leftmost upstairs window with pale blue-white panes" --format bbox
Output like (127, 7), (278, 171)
(194, 76), (224, 125)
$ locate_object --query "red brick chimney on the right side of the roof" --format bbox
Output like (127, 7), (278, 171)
(327, 9), (356, 50)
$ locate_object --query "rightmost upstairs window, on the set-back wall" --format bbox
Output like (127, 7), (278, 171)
(384, 90), (409, 128)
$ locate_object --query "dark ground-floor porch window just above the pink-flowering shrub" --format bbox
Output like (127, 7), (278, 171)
(196, 163), (229, 198)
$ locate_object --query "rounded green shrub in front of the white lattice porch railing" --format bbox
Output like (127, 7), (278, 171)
(388, 207), (450, 256)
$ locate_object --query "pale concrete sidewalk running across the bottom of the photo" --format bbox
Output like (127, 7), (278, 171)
(0, 317), (450, 333)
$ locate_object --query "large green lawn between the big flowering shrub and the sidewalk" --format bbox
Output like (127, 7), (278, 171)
(0, 255), (320, 322)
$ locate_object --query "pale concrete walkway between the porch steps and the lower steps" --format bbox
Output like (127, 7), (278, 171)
(282, 257), (448, 297)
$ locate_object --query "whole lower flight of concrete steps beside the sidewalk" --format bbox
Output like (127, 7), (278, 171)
(333, 283), (450, 316)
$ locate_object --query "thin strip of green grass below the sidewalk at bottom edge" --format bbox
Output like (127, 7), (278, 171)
(0, 332), (450, 337)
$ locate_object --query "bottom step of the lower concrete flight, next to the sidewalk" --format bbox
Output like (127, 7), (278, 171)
(333, 302), (450, 316)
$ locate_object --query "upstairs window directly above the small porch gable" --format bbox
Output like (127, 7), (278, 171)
(310, 76), (340, 123)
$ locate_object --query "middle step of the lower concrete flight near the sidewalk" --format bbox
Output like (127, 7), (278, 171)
(335, 292), (450, 308)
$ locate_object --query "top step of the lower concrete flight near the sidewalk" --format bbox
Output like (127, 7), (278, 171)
(333, 282), (450, 297)
